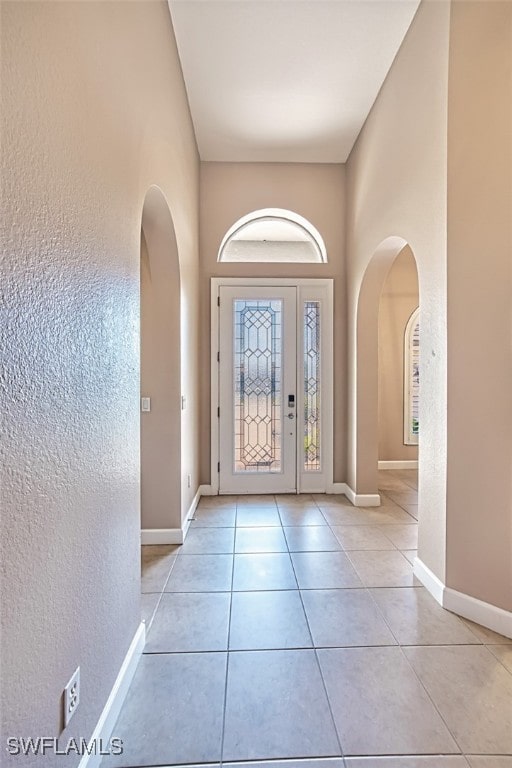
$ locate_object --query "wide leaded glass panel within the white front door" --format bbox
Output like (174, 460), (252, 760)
(233, 299), (283, 472)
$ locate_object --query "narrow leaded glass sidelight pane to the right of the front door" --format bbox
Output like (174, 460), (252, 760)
(304, 301), (321, 472)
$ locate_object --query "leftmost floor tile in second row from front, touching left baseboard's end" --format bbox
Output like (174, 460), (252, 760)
(144, 592), (231, 653)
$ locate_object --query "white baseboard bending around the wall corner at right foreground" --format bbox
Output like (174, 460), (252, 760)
(414, 557), (512, 638)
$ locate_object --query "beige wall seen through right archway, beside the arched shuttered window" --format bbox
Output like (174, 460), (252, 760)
(379, 246), (419, 461)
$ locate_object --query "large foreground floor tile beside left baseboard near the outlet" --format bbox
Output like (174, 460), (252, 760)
(102, 653), (227, 768)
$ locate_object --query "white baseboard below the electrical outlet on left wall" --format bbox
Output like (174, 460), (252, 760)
(78, 621), (146, 768)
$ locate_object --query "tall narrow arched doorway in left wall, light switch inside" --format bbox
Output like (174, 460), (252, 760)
(140, 186), (181, 544)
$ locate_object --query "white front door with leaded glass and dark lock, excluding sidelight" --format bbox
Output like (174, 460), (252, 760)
(219, 286), (297, 493)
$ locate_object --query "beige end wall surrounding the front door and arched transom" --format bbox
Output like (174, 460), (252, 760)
(200, 163), (346, 483)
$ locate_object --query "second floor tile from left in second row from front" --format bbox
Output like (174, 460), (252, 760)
(229, 590), (312, 650)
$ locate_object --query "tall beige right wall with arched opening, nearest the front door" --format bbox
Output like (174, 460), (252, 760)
(347, 2), (450, 580)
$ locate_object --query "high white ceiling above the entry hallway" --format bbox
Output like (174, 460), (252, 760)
(169, 0), (419, 163)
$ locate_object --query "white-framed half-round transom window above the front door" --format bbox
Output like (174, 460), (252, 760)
(218, 208), (327, 263)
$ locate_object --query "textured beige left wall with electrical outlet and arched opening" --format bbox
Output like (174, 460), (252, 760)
(0, 2), (199, 768)
